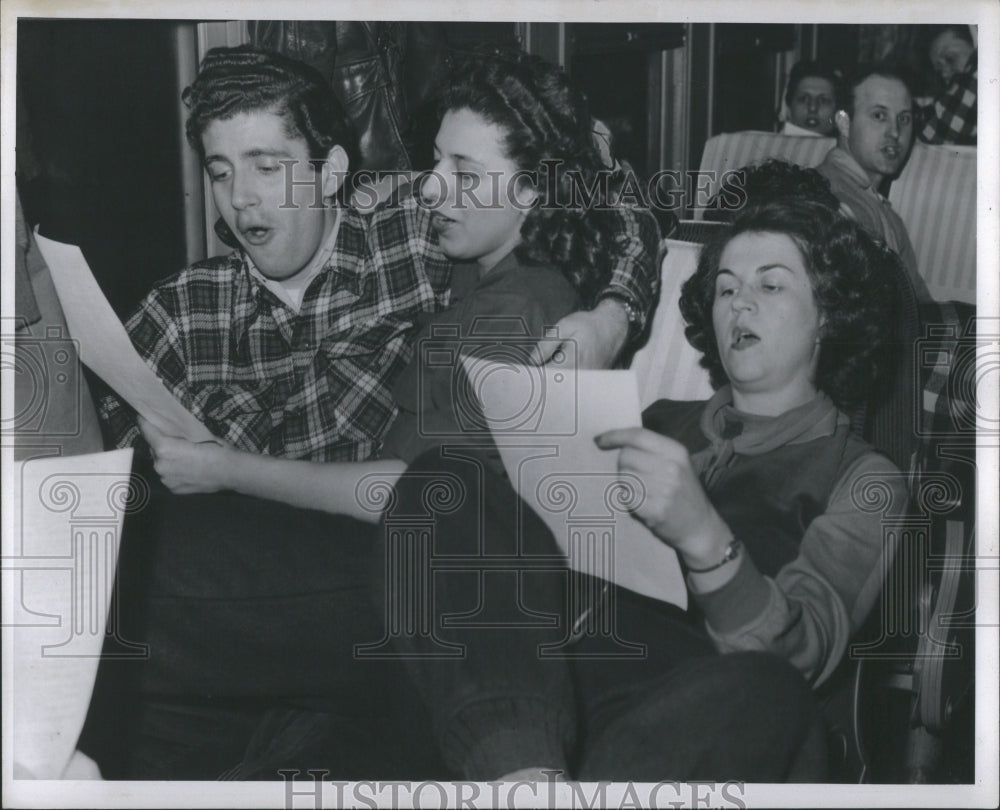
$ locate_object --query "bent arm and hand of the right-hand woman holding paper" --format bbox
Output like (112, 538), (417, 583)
(596, 428), (906, 684)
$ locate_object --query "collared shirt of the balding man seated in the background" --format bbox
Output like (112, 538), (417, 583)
(816, 146), (933, 301)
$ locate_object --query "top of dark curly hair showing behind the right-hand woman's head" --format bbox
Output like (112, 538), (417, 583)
(705, 158), (840, 222)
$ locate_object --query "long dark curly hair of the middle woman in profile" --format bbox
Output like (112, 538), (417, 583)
(441, 48), (616, 306)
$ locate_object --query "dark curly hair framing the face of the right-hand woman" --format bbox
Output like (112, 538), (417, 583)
(680, 198), (905, 410)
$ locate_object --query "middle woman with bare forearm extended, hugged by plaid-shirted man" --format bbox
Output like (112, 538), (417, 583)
(143, 44), (621, 504)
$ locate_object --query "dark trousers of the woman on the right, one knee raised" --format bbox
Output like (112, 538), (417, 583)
(379, 450), (825, 782)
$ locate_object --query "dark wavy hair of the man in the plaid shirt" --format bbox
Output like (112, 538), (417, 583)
(181, 45), (359, 181)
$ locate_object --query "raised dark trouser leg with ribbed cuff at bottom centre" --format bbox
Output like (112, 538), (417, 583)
(378, 448), (575, 780)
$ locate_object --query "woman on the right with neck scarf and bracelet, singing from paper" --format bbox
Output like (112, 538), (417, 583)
(577, 194), (906, 781)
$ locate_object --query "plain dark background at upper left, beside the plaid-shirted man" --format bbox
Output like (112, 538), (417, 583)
(17, 20), (184, 315)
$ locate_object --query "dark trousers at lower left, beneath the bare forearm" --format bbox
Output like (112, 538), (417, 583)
(81, 470), (441, 779)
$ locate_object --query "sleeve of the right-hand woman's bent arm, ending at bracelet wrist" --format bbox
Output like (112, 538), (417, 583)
(688, 453), (906, 685)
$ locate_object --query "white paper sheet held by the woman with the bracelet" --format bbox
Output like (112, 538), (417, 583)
(463, 356), (687, 607)
